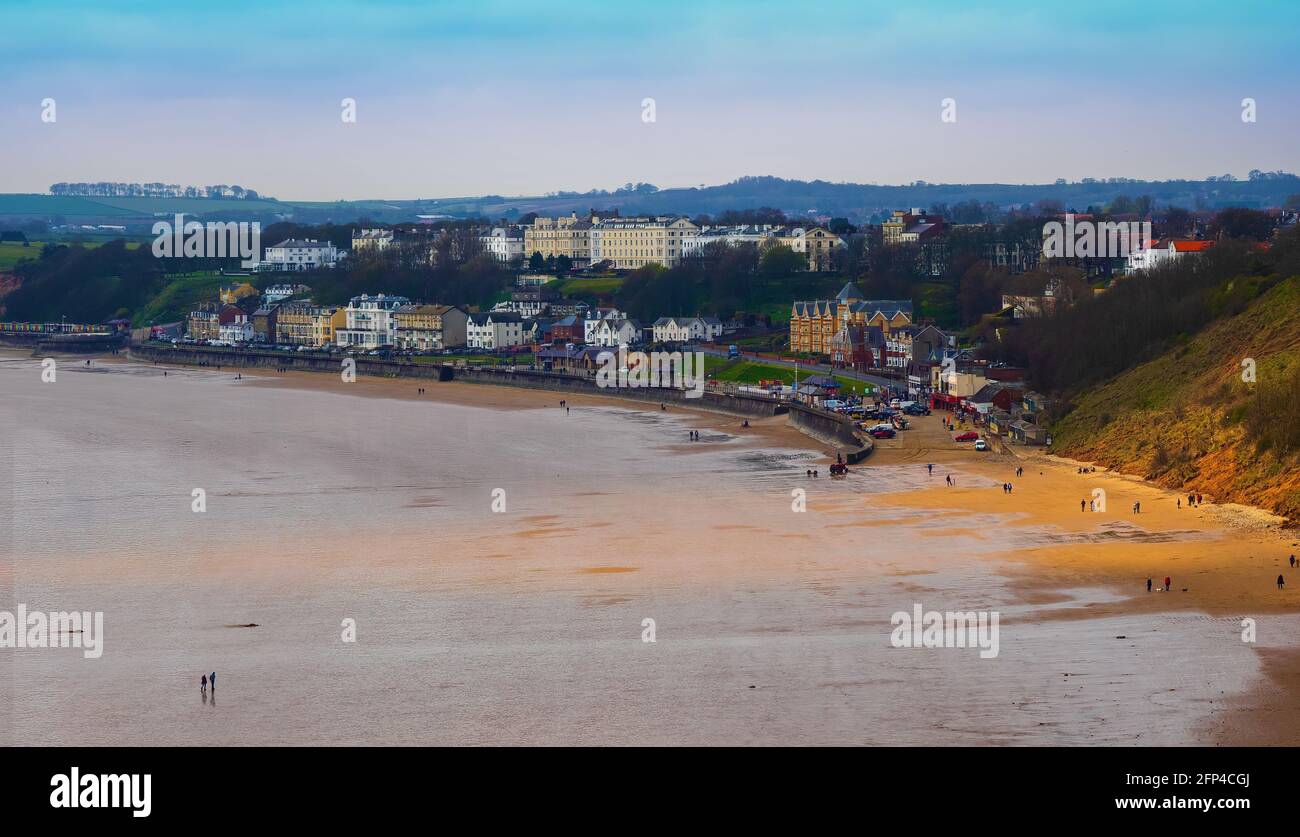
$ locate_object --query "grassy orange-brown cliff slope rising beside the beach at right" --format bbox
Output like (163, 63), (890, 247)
(1053, 277), (1300, 522)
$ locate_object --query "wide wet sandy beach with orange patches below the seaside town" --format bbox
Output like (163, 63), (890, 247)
(0, 345), (1300, 745)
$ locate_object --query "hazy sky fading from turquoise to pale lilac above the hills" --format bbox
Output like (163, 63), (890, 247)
(0, 0), (1300, 200)
